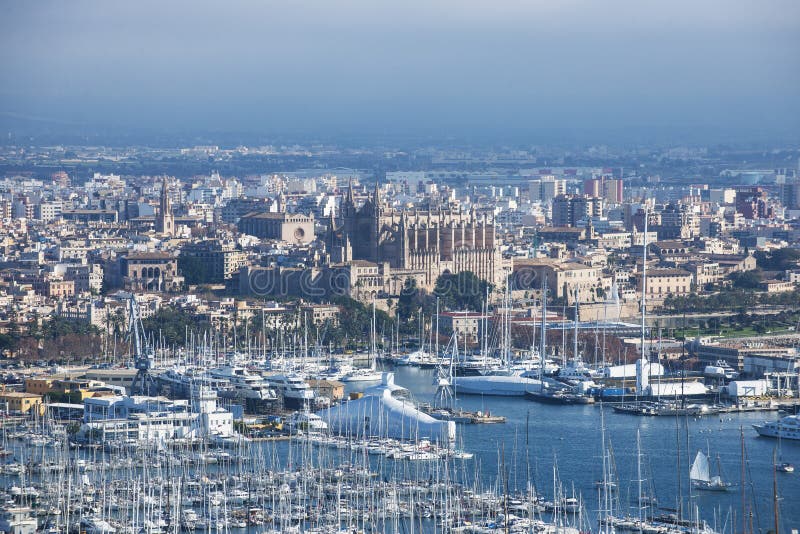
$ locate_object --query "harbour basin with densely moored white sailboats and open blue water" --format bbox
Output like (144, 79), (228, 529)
(2, 366), (800, 532)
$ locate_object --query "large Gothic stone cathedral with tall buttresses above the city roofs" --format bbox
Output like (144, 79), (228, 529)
(326, 184), (503, 289)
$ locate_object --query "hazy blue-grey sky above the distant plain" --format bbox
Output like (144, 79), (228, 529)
(0, 0), (800, 141)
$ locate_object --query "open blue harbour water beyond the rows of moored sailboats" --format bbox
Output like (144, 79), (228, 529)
(368, 367), (800, 532)
